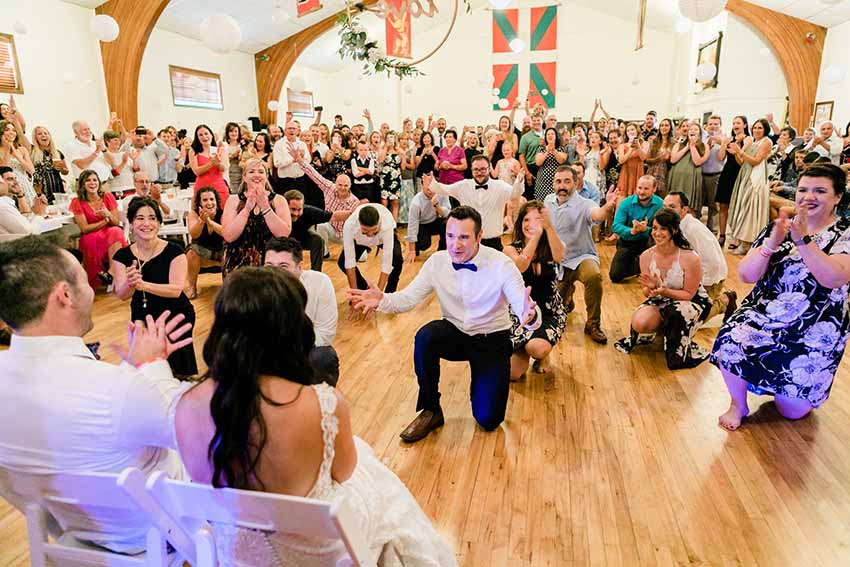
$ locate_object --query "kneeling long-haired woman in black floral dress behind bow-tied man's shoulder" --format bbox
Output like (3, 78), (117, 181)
(505, 201), (567, 380)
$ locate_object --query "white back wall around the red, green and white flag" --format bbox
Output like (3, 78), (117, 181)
(281, 3), (675, 127)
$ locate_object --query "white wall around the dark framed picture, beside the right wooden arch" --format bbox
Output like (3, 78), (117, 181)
(673, 12), (788, 129)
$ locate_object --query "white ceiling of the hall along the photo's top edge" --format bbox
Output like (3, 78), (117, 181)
(65, 0), (850, 60)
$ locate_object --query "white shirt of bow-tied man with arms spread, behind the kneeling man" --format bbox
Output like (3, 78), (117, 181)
(431, 175), (525, 238)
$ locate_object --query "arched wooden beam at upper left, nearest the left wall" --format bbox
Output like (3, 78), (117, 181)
(95, 0), (169, 128)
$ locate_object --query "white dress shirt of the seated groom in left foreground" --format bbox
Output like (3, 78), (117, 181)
(0, 335), (187, 552)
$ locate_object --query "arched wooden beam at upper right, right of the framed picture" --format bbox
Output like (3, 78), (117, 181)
(726, 0), (826, 130)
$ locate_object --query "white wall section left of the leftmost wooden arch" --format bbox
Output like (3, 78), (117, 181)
(0, 0), (109, 146)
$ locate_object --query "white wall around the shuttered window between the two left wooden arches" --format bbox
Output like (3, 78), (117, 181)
(137, 28), (258, 137)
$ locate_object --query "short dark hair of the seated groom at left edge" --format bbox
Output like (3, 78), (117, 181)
(0, 236), (77, 331)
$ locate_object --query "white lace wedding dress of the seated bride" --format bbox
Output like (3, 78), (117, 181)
(200, 384), (457, 567)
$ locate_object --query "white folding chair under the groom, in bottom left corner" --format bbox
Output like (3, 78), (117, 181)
(0, 468), (168, 567)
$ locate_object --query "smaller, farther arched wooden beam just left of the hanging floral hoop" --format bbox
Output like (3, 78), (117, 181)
(254, 12), (341, 124)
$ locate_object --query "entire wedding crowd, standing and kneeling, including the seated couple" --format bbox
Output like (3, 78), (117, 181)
(0, 89), (850, 565)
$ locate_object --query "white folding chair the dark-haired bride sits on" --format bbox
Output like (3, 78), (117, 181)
(128, 472), (377, 567)
